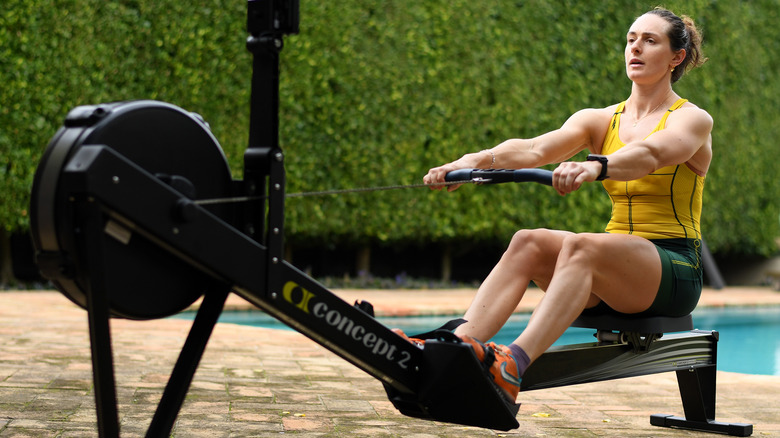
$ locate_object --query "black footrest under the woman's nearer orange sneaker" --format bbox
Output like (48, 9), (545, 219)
(385, 340), (520, 430)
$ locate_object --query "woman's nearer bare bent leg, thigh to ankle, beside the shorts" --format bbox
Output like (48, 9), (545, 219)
(514, 234), (661, 361)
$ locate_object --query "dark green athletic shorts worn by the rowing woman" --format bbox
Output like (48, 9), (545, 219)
(585, 239), (703, 317)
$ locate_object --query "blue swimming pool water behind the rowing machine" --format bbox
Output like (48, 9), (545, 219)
(182, 307), (780, 376)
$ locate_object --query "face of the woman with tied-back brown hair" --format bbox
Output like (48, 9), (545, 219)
(625, 14), (685, 84)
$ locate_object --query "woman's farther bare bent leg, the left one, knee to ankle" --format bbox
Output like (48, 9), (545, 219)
(455, 229), (573, 341)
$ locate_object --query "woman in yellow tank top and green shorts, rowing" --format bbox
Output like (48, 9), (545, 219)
(414, 8), (713, 401)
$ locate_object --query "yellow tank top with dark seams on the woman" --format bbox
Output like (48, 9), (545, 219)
(601, 99), (704, 239)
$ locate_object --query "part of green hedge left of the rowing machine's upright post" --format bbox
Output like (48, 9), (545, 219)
(0, 0), (251, 226)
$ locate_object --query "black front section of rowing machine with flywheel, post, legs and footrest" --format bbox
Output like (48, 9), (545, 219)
(30, 0), (748, 436)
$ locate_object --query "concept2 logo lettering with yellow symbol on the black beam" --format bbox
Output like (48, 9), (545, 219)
(282, 281), (411, 369)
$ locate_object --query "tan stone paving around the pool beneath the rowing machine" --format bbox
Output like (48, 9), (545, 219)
(0, 288), (780, 437)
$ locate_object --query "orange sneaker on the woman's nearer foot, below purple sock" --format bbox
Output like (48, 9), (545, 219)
(460, 335), (522, 403)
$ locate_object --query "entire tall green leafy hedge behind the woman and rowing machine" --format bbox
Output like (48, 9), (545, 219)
(0, 0), (780, 255)
